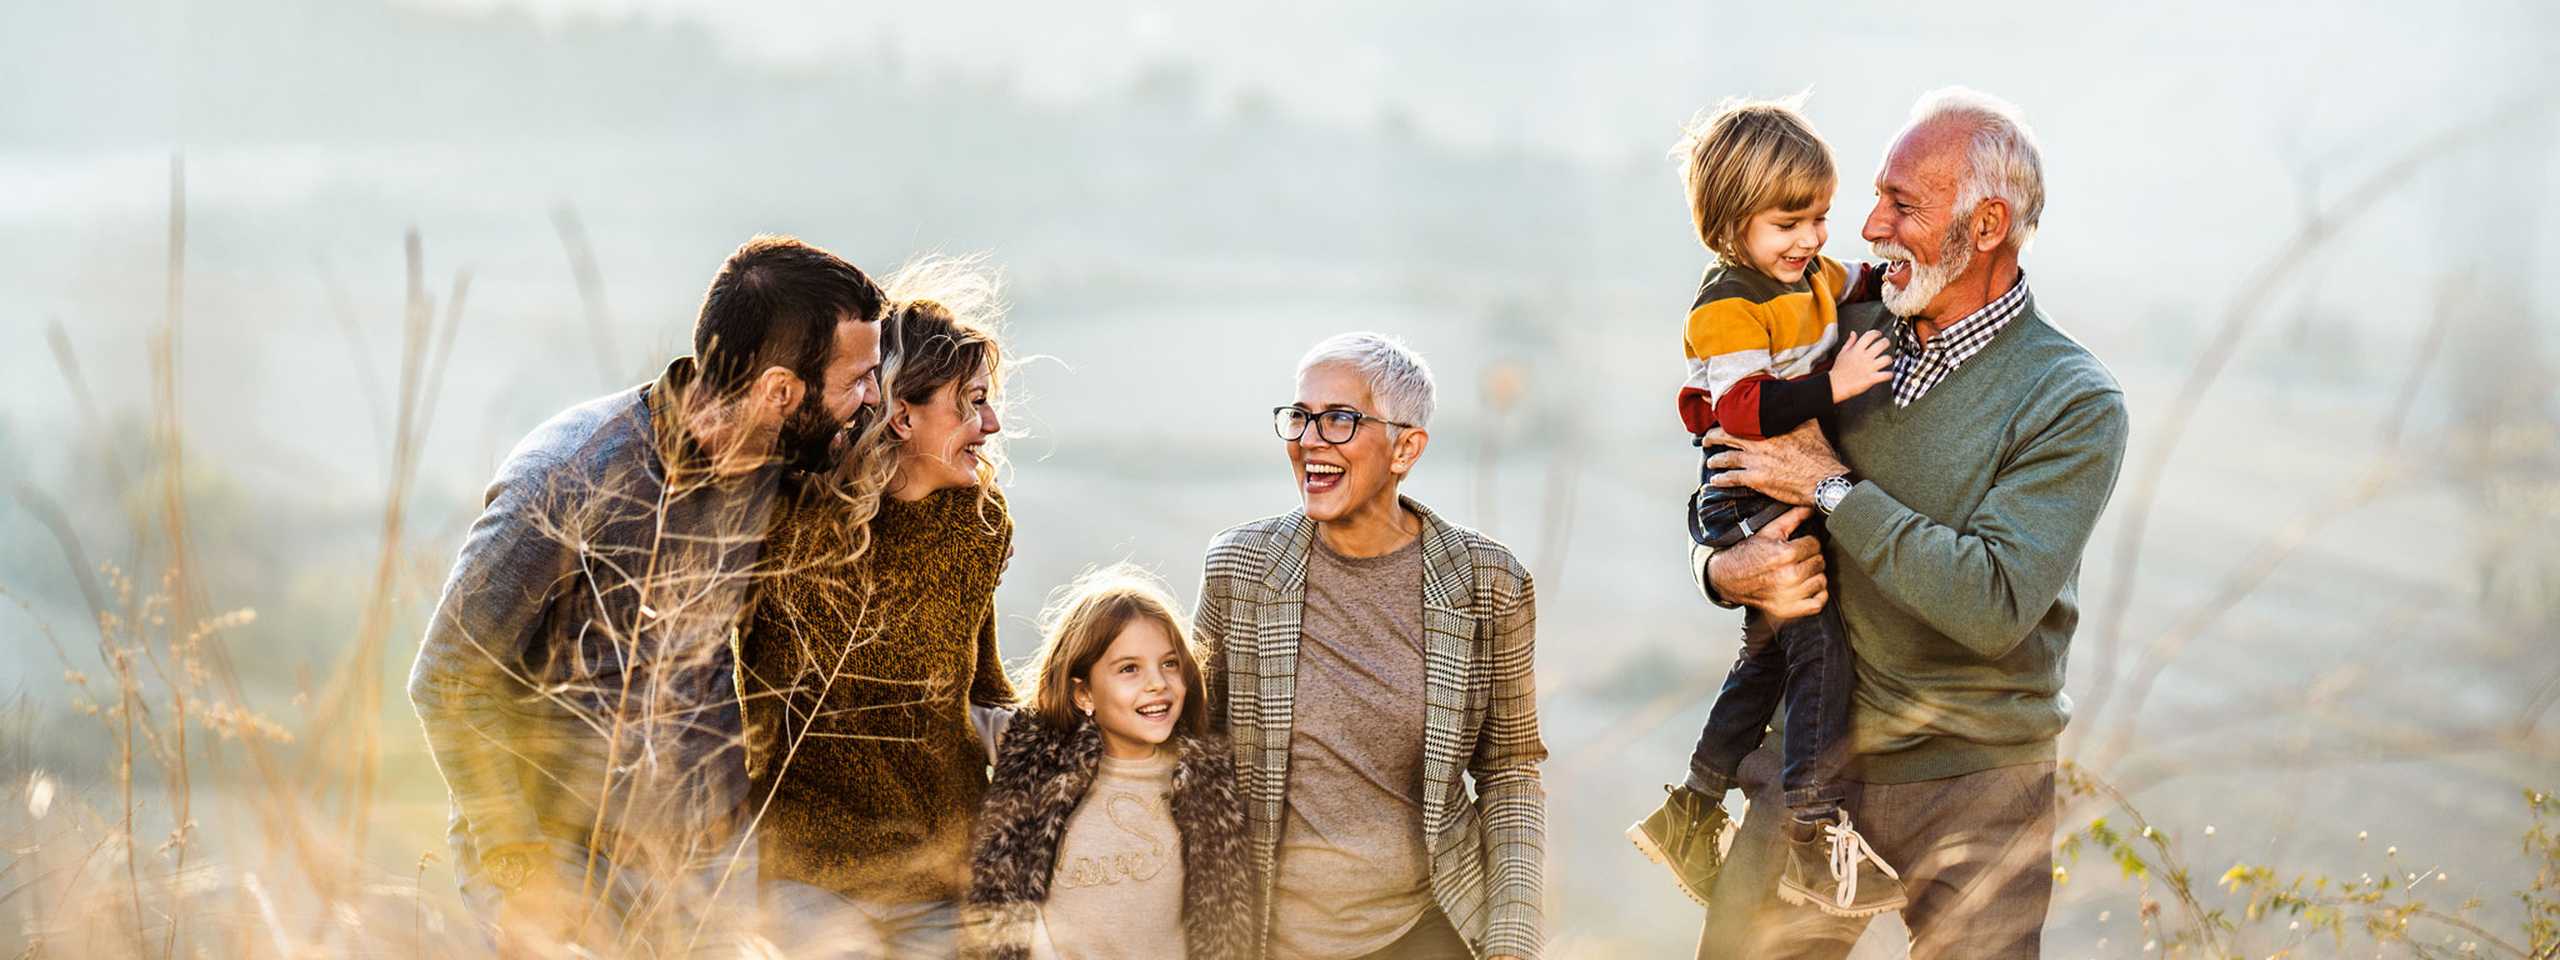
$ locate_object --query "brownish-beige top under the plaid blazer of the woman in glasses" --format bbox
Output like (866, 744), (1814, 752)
(1272, 535), (1431, 960)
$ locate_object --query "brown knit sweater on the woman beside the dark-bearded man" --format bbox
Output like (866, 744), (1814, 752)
(737, 489), (1014, 901)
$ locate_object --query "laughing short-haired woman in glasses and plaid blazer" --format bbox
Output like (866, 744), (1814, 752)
(1198, 333), (1546, 960)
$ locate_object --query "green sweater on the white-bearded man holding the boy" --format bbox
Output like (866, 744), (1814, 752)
(1830, 294), (2125, 783)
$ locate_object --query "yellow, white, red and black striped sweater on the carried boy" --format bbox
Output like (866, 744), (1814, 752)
(1679, 256), (1864, 440)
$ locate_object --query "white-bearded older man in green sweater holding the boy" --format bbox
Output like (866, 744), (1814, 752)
(1700, 90), (2125, 957)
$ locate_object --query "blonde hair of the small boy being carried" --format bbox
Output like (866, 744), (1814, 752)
(1672, 95), (1838, 264)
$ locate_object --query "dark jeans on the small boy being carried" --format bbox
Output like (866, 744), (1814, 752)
(1690, 535), (1859, 819)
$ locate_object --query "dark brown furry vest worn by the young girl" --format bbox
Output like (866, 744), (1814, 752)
(965, 712), (1252, 960)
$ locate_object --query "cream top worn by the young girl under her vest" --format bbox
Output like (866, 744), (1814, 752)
(1039, 750), (1185, 960)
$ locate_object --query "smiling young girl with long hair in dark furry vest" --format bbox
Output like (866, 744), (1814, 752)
(968, 566), (1249, 960)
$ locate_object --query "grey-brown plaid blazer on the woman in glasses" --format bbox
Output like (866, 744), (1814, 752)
(1196, 499), (1546, 960)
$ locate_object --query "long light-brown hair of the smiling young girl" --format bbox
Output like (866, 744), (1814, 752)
(1021, 563), (1208, 737)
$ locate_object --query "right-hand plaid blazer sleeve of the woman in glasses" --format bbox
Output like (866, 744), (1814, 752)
(1467, 571), (1546, 960)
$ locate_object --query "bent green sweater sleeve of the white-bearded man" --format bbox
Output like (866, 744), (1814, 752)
(1830, 392), (2125, 658)
